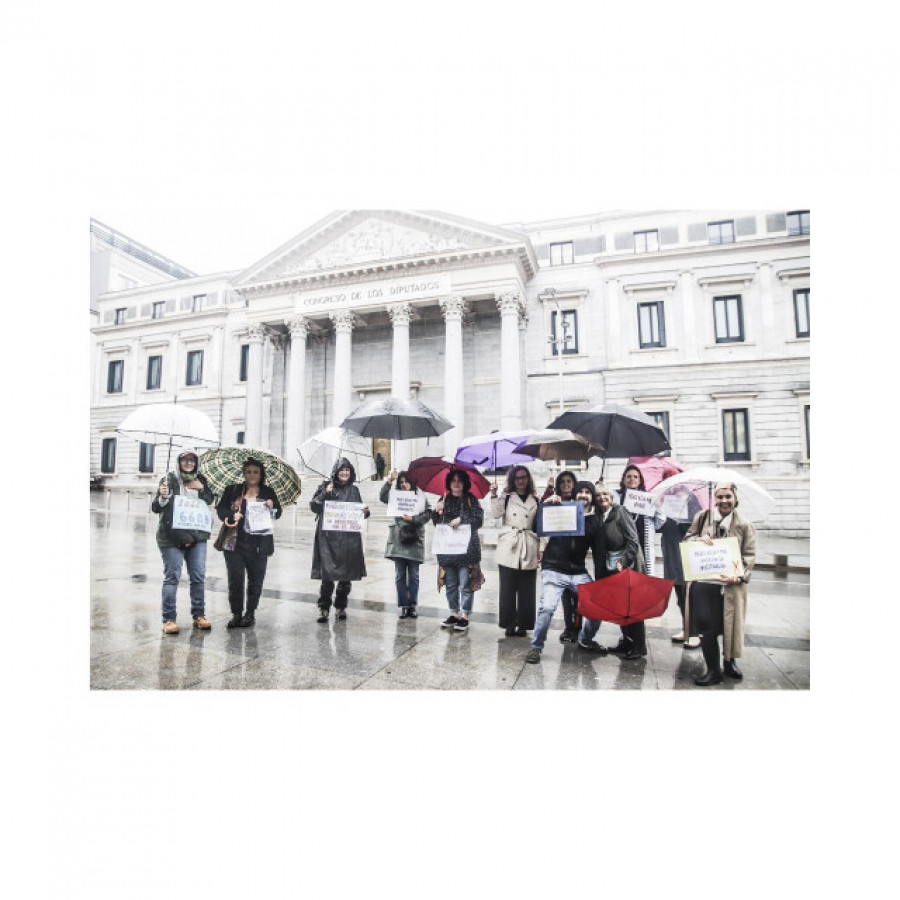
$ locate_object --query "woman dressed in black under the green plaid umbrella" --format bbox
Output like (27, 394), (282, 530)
(216, 456), (281, 628)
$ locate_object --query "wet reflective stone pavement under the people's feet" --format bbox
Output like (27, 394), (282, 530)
(90, 482), (809, 692)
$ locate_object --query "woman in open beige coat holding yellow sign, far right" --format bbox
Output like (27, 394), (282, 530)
(684, 483), (756, 687)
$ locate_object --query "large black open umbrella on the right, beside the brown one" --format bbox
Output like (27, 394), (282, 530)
(547, 403), (671, 477)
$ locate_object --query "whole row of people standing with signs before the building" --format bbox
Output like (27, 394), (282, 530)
(152, 451), (756, 687)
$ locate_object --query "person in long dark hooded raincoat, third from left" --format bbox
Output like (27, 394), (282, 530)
(309, 456), (369, 624)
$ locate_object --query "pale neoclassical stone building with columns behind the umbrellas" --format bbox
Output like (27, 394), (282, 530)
(91, 210), (810, 535)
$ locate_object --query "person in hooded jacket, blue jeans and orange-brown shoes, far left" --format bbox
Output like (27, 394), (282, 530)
(150, 450), (213, 634)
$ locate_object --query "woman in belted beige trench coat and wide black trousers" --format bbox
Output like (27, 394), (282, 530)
(491, 466), (538, 637)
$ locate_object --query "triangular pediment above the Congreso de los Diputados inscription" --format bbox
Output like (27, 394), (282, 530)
(234, 210), (526, 286)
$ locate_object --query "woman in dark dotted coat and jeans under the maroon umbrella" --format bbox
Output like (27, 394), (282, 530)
(432, 467), (484, 631)
